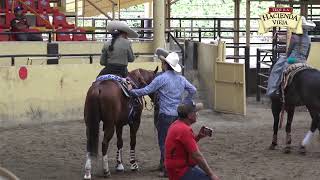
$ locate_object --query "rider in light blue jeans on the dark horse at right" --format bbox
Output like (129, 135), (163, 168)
(267, 16), (316, 98)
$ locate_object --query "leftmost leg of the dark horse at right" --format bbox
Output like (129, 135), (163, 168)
(269, 99), (282, 150)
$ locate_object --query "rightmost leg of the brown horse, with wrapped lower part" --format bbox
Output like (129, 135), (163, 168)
(130, 118), (140, 171)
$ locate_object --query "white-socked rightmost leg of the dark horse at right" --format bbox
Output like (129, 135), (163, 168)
(300, 106), (319, 154)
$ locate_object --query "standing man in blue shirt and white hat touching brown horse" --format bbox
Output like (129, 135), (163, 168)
(130, 49), (196, 177)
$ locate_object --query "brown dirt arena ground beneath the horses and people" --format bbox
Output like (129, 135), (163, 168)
(0, 97), (320, 180)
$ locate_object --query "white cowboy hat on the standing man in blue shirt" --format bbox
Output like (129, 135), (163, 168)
(156, 48), (182, 72)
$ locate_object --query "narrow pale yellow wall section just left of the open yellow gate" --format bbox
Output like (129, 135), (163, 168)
(198, 43), (218, 108)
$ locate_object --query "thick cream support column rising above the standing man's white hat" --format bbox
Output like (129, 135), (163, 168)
(153, 0), (166, 50)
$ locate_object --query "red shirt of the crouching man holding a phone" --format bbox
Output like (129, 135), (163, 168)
(164, 119), (198, 180)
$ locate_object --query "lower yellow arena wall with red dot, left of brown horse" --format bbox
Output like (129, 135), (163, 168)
(0, 62), (159, 127)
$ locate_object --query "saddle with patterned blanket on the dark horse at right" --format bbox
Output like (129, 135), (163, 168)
(281, 63), (313, 102)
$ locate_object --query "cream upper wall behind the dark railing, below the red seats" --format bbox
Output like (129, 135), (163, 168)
(0, 41), (153, 66)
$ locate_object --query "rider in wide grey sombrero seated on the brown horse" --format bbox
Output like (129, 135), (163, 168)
(99, 21), (138, 77)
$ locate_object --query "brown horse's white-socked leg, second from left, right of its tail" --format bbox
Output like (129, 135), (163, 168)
(102, 123), (114, 177)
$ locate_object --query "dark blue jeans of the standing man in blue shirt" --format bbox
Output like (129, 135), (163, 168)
(156, 113), (178, 169)
